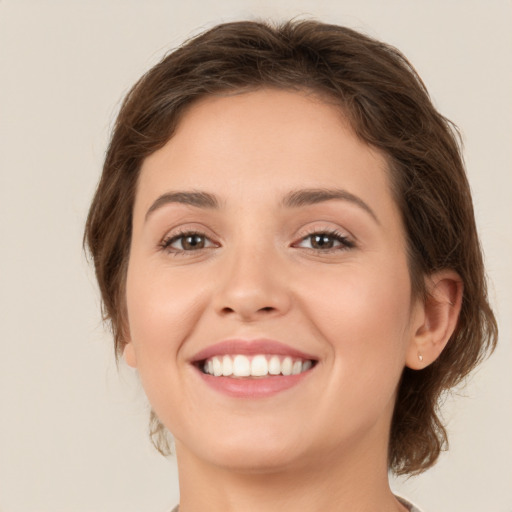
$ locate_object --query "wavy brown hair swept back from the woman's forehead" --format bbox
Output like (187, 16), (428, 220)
(84, 21), (497, 474)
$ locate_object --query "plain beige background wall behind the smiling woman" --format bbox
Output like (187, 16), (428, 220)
(0, 0), (512, 512)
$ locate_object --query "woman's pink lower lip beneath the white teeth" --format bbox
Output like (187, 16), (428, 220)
(198, 370), (311, 398)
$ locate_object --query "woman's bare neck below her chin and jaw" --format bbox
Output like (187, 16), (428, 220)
(176, 432), (405, 512)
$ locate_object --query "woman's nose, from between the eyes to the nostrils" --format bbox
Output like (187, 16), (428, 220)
(214, 243), (291, 322)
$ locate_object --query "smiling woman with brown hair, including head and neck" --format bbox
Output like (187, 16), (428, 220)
(85, 21), (497, 512)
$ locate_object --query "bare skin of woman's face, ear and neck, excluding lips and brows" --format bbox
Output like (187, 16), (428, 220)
(124, 90), (461, 512)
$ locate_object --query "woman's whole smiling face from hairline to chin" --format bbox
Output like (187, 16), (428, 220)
(125, 90), (421, 471)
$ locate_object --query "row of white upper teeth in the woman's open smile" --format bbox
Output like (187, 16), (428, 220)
(203, 354), (313, 377)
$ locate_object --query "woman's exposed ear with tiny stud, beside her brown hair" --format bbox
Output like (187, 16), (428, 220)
(406, 270), (464, 370)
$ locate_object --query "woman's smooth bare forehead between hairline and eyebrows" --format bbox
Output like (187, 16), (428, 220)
(137, 89), (396, 216)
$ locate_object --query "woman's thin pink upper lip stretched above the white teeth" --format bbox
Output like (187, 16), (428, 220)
(191, 338), (317, 363)
